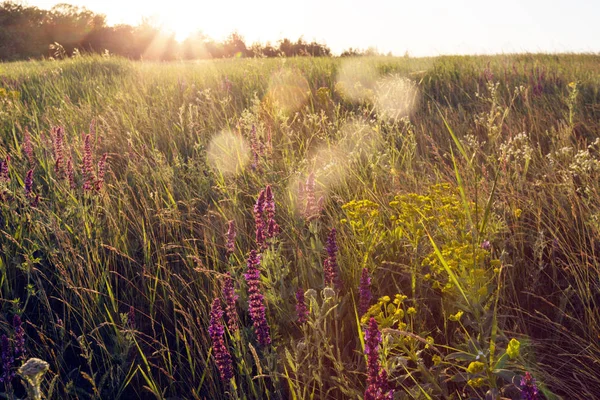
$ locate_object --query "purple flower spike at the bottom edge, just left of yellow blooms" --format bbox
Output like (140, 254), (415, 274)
(364, 317), (394, 400)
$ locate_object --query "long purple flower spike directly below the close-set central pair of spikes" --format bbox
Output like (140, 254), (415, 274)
(244, 250), (271, 346)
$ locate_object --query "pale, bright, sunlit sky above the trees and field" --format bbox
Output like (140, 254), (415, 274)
(25, 0), (600, 56)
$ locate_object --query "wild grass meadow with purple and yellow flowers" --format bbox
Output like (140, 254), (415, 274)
(0, 55), (600, 399)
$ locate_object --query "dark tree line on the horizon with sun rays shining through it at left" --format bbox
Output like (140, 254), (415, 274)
(0, 1), (346, 61)
